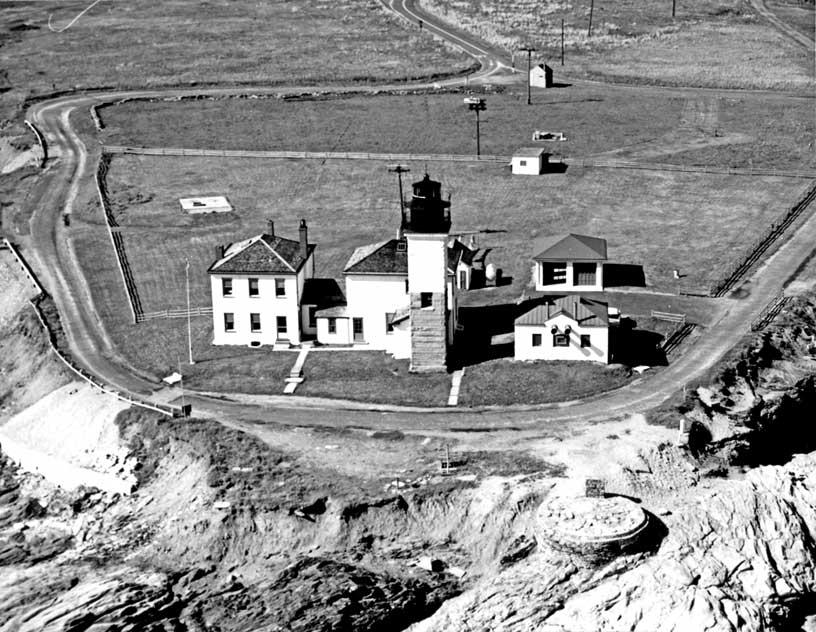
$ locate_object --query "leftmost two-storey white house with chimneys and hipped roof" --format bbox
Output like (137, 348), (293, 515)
(208, 220), (316, 346)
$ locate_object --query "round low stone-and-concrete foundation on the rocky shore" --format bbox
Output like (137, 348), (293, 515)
(537, 496), (649, 555)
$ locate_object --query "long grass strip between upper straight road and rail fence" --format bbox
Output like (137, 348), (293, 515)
(100, 86), (816, 168)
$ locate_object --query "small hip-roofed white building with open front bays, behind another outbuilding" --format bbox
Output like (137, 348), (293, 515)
(533, 233), (606, 292)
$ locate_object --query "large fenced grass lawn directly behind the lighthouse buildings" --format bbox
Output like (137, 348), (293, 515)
(94, 156), (804, 311)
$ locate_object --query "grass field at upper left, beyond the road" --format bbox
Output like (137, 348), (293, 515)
(0, 0), (473, 135)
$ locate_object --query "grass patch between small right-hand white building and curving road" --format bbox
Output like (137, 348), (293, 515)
(459, 360), (631, 406)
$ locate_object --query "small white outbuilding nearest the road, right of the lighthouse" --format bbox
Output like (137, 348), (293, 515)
(514, 296), (609, 364)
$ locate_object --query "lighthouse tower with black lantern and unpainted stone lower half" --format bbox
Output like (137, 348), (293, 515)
(402, 174), (456, 373)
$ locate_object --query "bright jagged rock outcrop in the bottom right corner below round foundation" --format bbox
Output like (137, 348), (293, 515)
(411, 455), (816, 632)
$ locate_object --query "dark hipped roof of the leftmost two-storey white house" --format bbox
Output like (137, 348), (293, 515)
(208, 235), (315, 274)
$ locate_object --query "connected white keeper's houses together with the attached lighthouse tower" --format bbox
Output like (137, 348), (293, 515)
(209, 174), (466, 372)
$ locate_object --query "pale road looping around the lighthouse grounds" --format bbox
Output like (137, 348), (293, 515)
(17, 0), (816, 430)
